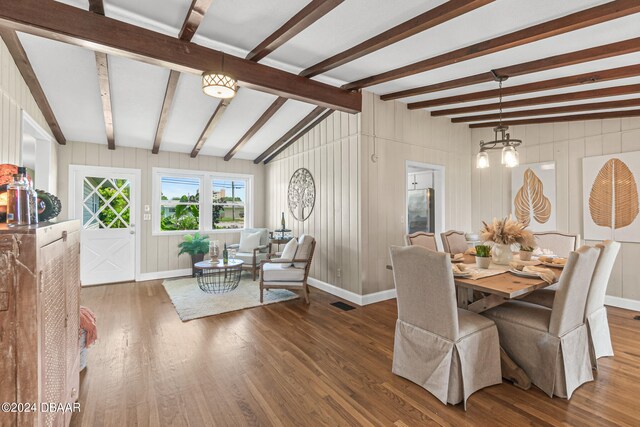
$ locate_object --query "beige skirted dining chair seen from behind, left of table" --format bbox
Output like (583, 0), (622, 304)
(390, 246), (502, 409)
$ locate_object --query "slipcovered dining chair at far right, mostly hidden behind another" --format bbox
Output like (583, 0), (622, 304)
(522, 240), (620, 369)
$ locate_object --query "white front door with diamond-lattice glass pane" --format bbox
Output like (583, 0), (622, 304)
(69, 167), (137, 286)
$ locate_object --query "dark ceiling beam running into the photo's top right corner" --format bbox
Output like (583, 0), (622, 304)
(343, 0), (640, 89)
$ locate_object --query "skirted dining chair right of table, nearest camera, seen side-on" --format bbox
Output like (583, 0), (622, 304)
(482, 246), (599, 399)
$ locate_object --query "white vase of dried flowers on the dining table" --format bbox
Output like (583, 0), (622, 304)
(480, 215), (535, 265)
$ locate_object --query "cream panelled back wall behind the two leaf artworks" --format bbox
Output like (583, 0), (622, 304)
(471, 118), (640, 300)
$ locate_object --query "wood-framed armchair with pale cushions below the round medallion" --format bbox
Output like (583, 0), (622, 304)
(260, 234), (316, 304)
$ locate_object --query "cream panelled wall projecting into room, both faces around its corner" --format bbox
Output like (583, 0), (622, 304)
(266, 92), (471, 295)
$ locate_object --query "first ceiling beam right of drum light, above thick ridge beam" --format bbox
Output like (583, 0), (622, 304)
(247, 0), (344, 62)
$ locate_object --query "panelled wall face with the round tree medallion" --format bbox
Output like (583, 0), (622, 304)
(266, 112), (362, 294)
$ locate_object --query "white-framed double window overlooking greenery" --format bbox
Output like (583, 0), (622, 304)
(152, 168), (253, 235)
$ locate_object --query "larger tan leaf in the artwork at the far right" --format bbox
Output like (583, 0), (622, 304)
(589, 159), (638, 229)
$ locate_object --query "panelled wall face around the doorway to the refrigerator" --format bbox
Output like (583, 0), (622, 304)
(361, 92), (471, 294)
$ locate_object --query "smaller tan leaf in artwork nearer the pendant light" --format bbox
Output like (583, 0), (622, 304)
(513, 169), (551, 225)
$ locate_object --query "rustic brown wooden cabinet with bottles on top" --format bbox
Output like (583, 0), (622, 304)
(0, 221), (80, 426)
